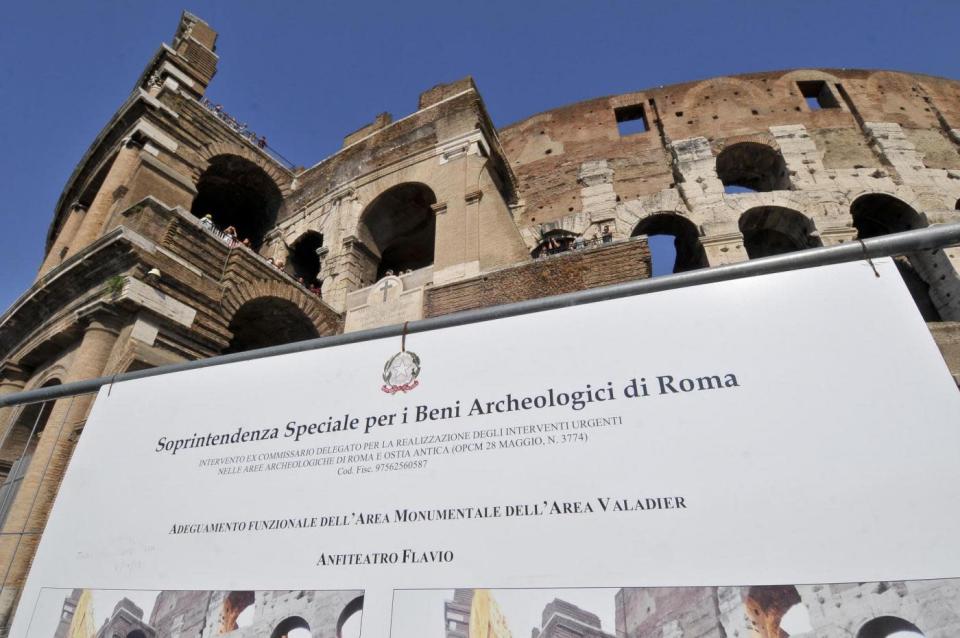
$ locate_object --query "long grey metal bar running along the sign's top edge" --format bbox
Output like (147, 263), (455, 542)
(0, 223), (960, 407)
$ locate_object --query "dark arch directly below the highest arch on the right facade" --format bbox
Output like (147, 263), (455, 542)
(740, 206), (822, 259)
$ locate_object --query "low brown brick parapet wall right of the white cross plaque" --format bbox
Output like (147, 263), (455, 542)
(424, 237), (650, 317)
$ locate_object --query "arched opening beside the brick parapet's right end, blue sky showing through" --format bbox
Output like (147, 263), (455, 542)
(631, 213), (707, 277)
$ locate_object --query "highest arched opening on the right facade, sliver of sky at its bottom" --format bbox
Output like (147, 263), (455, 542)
(717, 142), (790, 193)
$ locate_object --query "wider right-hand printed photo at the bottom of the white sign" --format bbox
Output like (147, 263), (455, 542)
(390, 579), (960, 638)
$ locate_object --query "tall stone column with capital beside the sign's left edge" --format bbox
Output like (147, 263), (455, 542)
(0, 304), (120, 635)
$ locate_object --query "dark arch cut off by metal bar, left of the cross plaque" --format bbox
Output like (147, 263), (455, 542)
(224, 297), (320, 353)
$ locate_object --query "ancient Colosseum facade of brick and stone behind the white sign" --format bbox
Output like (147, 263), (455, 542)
(0, 7), (960, 626)
